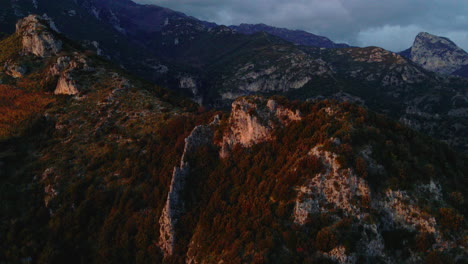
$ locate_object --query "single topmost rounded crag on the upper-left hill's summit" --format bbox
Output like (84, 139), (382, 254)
(16, 15), (62, 57)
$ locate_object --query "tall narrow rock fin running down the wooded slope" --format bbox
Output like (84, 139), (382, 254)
(159, 119), (217, 256)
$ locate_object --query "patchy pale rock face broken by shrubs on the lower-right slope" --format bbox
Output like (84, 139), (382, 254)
(293, 143), (453, 263)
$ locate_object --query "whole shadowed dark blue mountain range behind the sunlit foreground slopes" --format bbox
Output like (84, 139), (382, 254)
(0, 0), (468, 151)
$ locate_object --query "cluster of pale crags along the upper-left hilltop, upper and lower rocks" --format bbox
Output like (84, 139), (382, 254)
(4, 15), (95, 95)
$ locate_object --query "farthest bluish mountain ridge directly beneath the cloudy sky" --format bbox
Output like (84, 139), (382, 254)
(229, 24), (349, 48)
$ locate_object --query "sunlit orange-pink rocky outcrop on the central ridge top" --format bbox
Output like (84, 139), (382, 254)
(220, 96), (301, 157)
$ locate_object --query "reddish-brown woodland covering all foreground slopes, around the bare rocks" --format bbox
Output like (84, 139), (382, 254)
(0, 13), (468, 264)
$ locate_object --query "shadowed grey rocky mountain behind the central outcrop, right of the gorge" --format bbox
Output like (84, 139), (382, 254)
(202, 42), (468, 153)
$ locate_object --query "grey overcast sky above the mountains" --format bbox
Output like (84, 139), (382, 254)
(134, 0), (468, 51)
